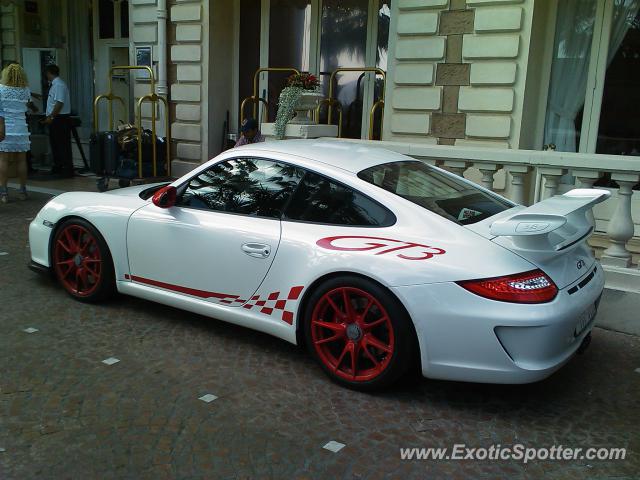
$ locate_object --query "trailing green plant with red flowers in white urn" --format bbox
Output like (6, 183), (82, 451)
(275, 73), (322, 139)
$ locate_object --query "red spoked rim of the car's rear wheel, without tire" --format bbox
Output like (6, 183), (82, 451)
(311, 287), (395, 382)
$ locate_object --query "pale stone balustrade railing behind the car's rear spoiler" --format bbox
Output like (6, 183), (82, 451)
(324, 139), (640, 292)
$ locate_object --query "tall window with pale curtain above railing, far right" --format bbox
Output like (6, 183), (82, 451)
(544, 0), (640, 155)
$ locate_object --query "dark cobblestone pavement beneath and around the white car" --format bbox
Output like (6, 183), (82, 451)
(0, 192), (640, 480)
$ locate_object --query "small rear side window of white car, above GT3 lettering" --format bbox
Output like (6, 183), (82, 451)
(285, 172), (395, 227)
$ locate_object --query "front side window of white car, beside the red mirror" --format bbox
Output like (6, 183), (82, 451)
(177, 158), (303, 218)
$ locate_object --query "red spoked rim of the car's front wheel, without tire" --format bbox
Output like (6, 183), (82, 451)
(53, 224), (102, 297)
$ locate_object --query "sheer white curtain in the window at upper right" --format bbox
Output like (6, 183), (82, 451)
(544, 0), (596, 152)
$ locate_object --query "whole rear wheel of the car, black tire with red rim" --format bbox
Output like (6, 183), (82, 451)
(303, 275), (418, 391)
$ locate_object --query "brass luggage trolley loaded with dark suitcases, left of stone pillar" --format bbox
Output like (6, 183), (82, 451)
(91, 65), (171, 191)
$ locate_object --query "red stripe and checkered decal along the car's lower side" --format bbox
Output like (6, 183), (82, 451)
(124, 275), (304, 325)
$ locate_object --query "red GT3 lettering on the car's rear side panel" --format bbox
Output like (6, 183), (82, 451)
(316, 235), (446, 260)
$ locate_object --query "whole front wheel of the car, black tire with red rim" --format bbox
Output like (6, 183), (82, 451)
(51, 218), (116, 303)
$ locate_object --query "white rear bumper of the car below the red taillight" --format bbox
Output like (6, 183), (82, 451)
(393, 265), (604, 383)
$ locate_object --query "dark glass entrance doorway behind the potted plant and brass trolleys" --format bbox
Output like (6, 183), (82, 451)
(236, 0), (391, 138)
